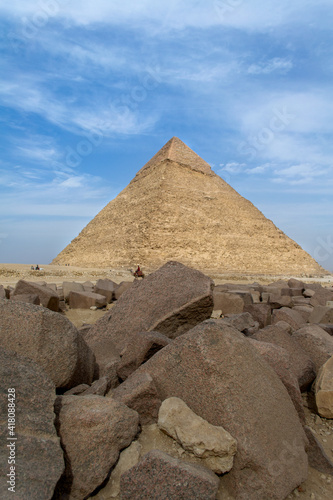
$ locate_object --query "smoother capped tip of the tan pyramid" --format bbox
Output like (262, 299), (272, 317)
(137, 136), (213, 175)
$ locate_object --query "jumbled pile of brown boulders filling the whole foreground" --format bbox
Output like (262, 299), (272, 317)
(0, 262), (333, 500)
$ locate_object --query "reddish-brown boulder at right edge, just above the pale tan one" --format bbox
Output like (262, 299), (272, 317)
(292, 325), (333, 372)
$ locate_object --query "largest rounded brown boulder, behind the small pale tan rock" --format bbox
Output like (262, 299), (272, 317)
(133, 320), (307, 500)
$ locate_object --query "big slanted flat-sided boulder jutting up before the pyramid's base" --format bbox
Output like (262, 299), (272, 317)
(86, 262), (213, 367)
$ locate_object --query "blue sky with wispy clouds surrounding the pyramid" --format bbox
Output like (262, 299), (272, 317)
(0, 0), (333, 271)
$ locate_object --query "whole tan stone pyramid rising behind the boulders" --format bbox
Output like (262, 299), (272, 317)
(52, 137), (324, 275)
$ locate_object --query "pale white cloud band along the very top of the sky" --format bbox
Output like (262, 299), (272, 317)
(0, 0), (331, 33)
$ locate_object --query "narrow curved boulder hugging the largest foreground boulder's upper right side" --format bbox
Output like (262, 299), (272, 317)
(252, 325), (316, 391)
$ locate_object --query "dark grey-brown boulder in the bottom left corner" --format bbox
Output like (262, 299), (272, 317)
(0, 349), (65, 500)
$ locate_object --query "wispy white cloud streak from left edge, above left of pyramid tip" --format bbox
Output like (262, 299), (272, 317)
(0, 75), (157, 137)
